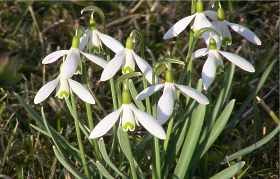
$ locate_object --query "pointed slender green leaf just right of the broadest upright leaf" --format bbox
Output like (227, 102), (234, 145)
(200, 99), (235, 158)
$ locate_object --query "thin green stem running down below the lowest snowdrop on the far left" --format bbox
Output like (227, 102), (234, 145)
(65, 93), (90, 178)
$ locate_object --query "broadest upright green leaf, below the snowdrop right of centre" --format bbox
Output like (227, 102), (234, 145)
(174, 105), (206, 178)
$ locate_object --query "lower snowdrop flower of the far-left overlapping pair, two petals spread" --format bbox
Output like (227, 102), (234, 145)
(34, 63), (95, 104)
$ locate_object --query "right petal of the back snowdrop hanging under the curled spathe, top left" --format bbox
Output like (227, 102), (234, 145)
(98, 32), (124, 53)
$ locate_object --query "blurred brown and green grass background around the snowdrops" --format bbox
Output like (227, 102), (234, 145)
(0, 0), (279, 179)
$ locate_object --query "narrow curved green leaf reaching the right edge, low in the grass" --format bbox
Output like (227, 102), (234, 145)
(225, 126), (280, 162)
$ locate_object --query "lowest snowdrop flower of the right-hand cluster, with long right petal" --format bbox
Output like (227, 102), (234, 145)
(192, 39), (255, 90)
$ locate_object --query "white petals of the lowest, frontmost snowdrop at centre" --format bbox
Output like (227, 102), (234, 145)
(89, 103), (166, 139)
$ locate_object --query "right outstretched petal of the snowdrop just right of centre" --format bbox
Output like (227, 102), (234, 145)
(176, 84), (209, 104)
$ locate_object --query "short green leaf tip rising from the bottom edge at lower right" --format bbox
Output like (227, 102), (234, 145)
(210, 161), (245, 179)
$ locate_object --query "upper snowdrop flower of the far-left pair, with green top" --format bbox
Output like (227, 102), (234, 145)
(42, 36), (107, 78)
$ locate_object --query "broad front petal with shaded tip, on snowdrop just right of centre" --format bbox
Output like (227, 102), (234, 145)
(157, 83), (175, 124)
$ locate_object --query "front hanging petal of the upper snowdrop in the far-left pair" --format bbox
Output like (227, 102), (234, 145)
(61, 48), (80, 79)
